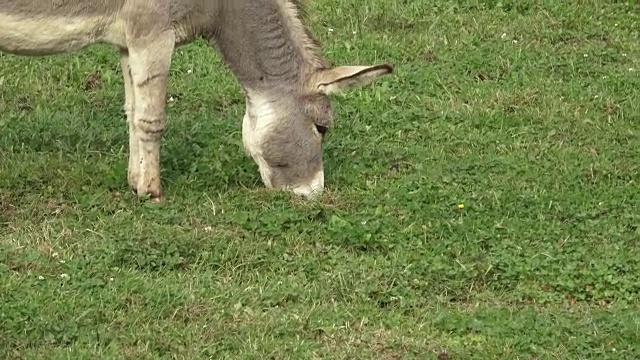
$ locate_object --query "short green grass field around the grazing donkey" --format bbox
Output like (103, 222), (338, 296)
(0, 0), (640, 360)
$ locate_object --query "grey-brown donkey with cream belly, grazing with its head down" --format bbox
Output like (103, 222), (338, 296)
(0, 0), (393, 200)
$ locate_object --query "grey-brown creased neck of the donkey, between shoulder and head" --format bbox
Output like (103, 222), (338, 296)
(210, 0), (326, 93)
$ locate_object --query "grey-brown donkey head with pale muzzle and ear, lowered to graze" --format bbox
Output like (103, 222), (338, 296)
(242, 65), (393, 198)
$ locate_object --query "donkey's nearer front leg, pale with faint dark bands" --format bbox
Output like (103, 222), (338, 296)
(123, 31), (175, 201)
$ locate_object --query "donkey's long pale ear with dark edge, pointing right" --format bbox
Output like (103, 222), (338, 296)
(311, 64), (393, 95)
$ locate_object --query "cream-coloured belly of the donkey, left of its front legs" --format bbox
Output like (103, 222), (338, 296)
(0, 12), (124, 55)
